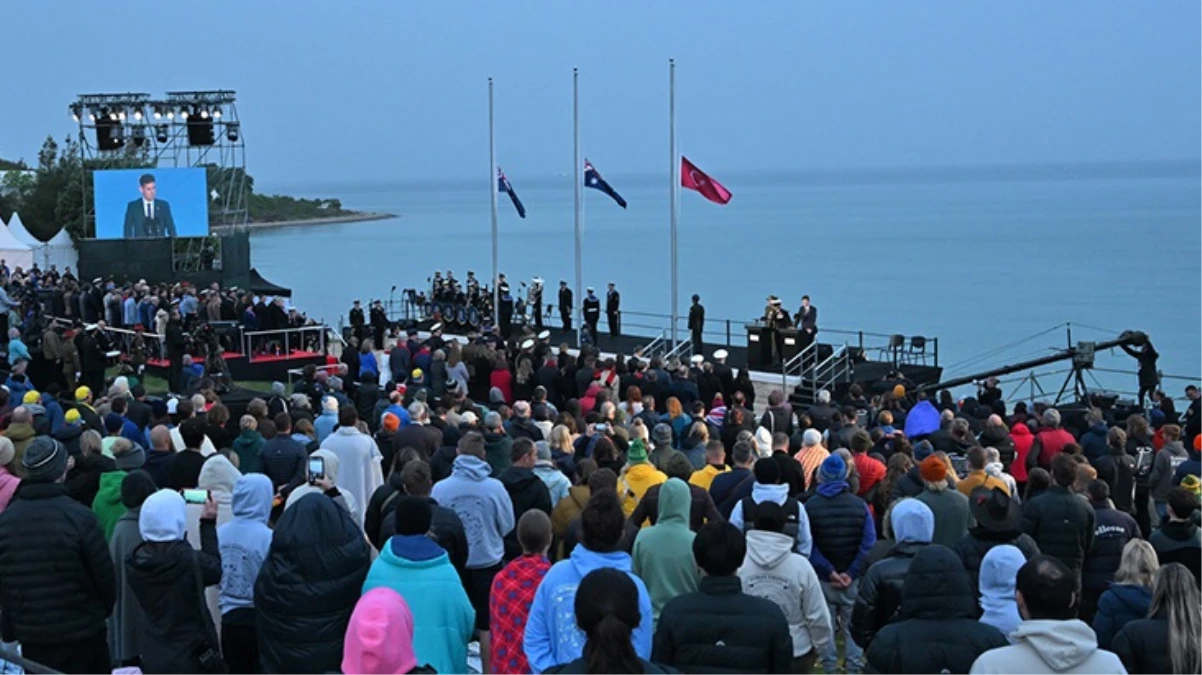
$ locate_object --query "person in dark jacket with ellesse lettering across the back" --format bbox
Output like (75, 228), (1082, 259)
(1077, 480), (1139, 623)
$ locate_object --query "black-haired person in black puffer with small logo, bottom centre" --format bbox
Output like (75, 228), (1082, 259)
(651, 522), (793, 674)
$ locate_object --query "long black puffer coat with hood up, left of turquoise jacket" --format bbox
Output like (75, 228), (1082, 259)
(255, 487), (370, 675)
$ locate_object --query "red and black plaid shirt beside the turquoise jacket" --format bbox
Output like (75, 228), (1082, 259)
(488, 555), (551, 675)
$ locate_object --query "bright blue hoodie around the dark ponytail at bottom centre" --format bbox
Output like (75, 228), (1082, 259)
(523, 545), (653, 673)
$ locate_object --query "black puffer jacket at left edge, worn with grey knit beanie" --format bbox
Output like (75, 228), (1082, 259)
(0, 482), (117, 645)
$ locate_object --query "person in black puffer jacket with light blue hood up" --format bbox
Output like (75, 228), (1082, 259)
(851, 497), (935, 649)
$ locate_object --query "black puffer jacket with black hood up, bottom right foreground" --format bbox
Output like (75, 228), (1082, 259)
(864, 544), (1010, 675)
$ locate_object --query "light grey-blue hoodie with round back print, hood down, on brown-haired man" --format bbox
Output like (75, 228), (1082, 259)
(430, 455), (514, 566)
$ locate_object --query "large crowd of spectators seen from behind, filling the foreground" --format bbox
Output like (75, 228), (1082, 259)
(0, 306), (1202, 675)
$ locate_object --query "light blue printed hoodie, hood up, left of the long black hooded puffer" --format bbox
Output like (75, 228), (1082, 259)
(218, 473), (275, 615)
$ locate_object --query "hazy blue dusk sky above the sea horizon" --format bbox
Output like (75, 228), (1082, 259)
(0, 0), (1202, 184)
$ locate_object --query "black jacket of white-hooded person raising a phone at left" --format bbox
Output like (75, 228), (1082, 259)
(124, 520), (221, 675)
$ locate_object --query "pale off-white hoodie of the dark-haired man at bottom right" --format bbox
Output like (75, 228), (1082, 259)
(970, 619), (1126, 675)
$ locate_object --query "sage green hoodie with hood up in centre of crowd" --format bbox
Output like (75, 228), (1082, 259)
(633, 478), (701, 621)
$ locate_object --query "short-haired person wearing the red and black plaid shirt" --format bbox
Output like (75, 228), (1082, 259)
(488, 509), (552, 675)
